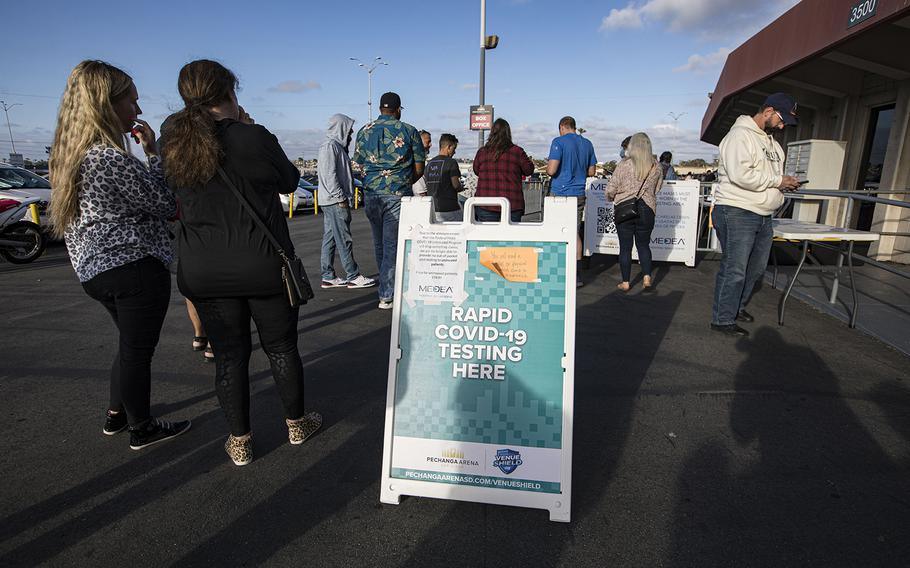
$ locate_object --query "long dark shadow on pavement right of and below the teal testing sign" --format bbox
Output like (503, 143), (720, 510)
(399, 286), (683, 567)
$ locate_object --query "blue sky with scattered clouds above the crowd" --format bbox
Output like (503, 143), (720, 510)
(0, 0), (796, 161)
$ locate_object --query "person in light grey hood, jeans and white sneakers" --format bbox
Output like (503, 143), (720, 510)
(316, 114), (376, 288)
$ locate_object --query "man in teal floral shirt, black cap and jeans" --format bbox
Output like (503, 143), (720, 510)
(353, 93), (426, 310)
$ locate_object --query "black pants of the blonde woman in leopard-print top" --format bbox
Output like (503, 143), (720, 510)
(82, 256), (171, 427)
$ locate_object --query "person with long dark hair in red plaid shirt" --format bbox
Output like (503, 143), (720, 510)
(474, 118), (534, 223)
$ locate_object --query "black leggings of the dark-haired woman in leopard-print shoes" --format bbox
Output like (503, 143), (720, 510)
(193, 294), (303, 436)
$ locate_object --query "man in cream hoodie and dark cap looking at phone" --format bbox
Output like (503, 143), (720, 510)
(711, 93), (799, 336)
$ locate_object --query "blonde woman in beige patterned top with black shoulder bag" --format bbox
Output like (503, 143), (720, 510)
(607, 132), (663, 292)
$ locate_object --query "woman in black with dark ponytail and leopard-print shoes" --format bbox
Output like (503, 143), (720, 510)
(162, 60), (322, 465)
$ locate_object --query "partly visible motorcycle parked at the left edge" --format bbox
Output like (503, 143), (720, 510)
(0, 191), (47, 264)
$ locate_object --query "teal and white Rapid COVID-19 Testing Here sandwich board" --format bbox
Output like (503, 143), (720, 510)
(380, 197), (576, 522)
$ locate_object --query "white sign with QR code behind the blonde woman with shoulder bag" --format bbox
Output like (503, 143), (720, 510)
(584, 179), (700, 266)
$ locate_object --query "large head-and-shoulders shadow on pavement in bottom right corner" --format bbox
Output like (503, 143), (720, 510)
(667, 327), (910, 567)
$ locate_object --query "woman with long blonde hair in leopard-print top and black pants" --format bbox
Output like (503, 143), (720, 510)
(50, 61), (190, 450)
